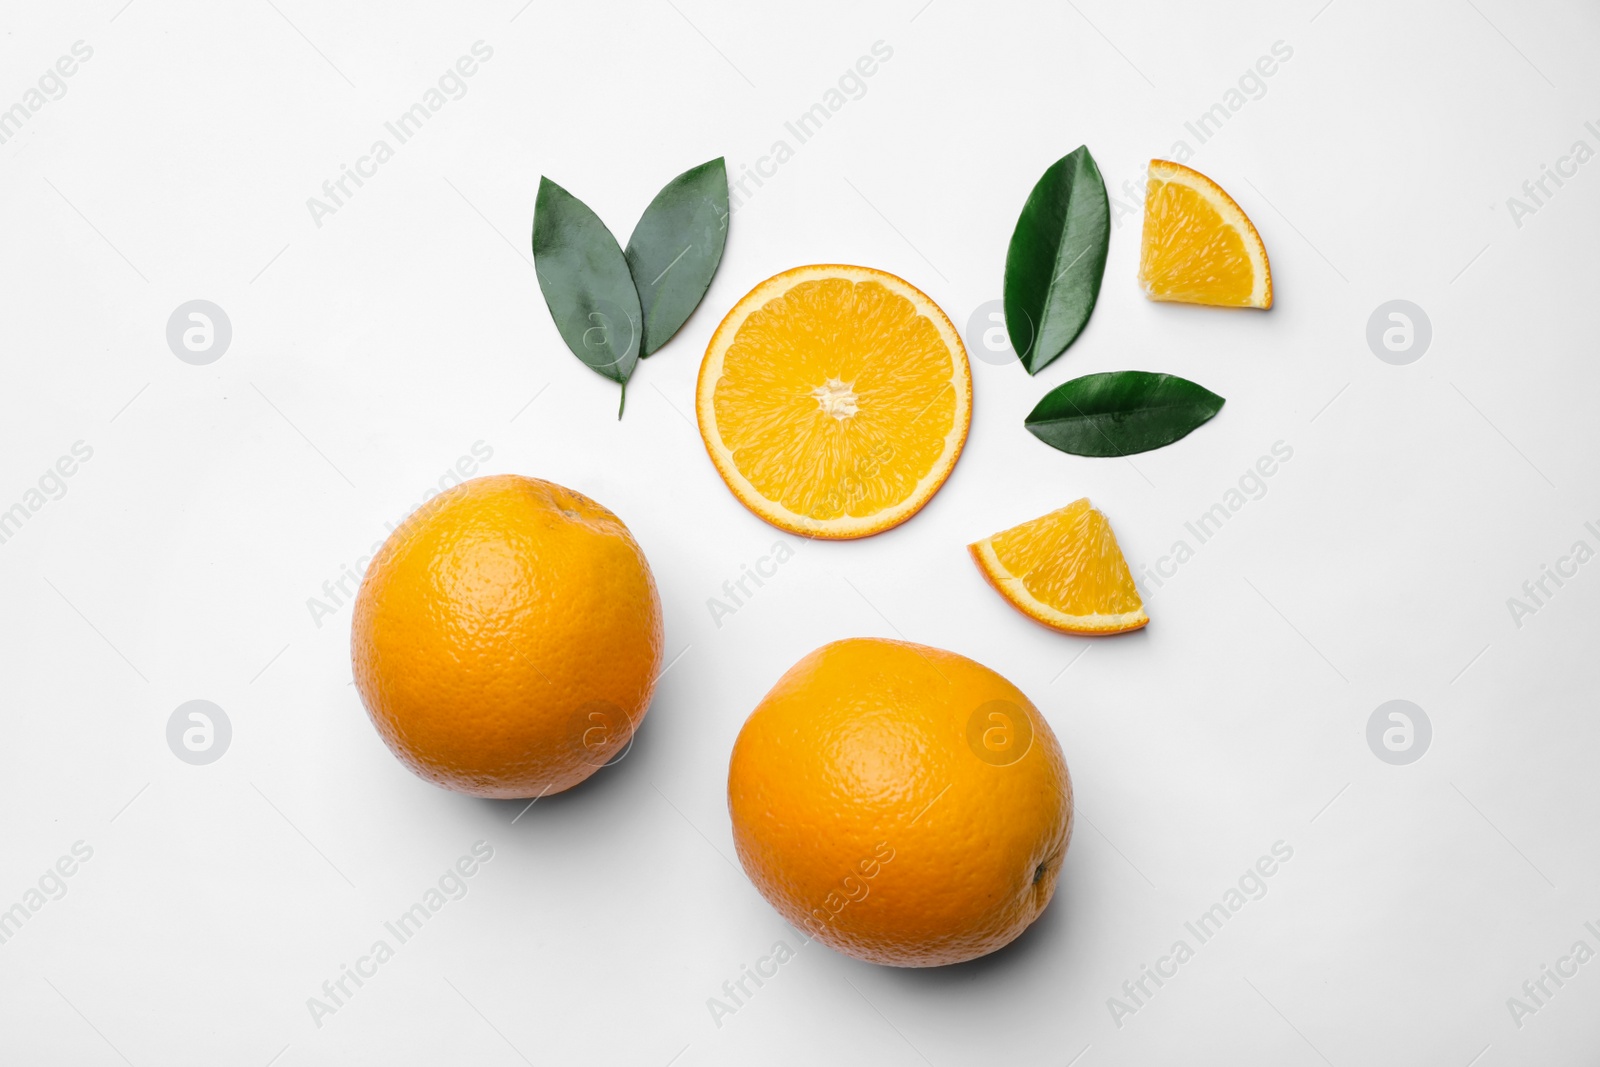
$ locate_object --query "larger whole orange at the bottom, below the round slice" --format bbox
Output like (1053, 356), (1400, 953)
(728, 638), (1074, 966)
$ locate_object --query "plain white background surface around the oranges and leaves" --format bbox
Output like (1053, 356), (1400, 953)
(0, 0), (1600, 1067)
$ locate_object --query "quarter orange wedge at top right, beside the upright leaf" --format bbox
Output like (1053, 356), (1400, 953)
(1139, 160), (1272, 307)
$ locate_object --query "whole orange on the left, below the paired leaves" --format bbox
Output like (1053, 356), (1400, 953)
(350, 475), (662, 798)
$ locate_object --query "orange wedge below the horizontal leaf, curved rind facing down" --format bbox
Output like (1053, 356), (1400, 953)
(966, 498), (1150, 635)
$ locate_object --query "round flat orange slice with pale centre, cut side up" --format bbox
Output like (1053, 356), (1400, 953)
(694, 264), (973, 539)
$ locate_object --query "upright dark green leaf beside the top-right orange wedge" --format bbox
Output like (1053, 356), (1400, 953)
(1005, 146), (1110, 374)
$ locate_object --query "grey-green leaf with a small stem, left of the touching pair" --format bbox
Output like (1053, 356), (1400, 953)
(533, 178), (642, 391)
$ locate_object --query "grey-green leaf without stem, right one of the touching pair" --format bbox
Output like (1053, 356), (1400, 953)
(626, 155), (728, 358)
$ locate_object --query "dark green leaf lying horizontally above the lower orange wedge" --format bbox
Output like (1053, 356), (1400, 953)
(1022, 371), (1226, 456)
